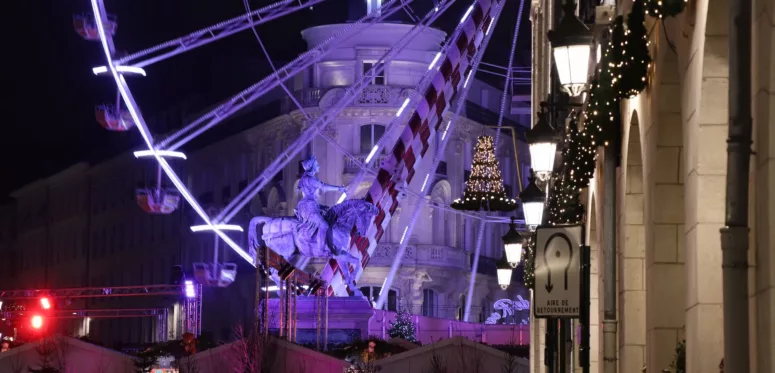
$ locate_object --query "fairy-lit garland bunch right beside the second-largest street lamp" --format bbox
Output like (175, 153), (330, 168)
(562, 112), (597, 191)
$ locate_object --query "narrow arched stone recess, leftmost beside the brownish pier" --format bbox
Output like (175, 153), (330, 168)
(617, 110), (646, 372)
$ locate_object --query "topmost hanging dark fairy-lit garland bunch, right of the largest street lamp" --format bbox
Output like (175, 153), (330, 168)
(612, 0), (651, 98)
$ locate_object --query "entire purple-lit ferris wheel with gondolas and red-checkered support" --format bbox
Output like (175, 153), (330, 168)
(74, 0), (524, 318)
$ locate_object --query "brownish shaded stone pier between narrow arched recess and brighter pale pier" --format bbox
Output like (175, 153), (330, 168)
(644, 16), (688, 372)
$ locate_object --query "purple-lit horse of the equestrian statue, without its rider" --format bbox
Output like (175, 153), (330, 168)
(248, 199), (378, 296)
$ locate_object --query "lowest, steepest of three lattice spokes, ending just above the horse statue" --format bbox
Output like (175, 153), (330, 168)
(215, 0), (454, 223)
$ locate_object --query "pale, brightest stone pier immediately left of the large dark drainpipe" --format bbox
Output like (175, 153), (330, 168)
(676, 0), (732, 372)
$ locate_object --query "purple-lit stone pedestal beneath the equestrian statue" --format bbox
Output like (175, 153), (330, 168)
(269, 296), (374, 344)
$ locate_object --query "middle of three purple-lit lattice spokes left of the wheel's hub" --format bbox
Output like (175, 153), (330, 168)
(157, 0), (422, 150)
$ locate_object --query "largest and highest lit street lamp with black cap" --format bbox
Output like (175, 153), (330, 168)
(548, 0), (594, 97)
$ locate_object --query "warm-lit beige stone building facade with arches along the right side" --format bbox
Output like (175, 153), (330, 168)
(531, 0), (775, 373)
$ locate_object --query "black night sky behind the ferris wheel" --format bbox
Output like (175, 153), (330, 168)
(0, 0), (530, 196)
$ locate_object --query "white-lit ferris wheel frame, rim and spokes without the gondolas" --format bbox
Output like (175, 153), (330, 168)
(90, 0), (524, 310)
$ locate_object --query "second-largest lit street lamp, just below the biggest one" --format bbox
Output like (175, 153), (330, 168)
(525, 102), (560, 179)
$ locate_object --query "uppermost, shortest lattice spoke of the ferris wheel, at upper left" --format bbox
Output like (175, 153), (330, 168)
(116, 0), (326, 67)
